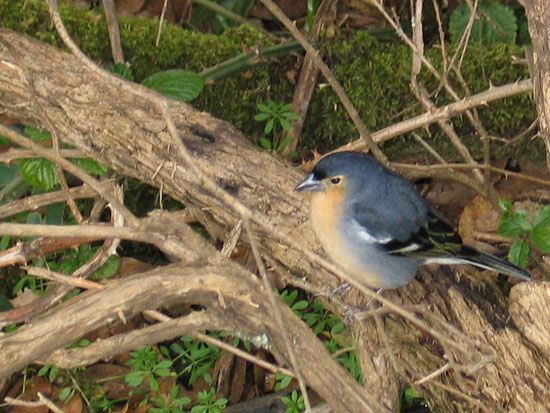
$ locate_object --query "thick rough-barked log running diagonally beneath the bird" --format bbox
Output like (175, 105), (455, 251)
(0, 30), (550, 412)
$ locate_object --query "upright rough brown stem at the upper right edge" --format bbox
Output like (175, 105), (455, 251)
(520, 0), (550, 169)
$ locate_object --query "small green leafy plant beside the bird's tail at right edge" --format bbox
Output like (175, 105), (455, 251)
(498, 199), (550, 268)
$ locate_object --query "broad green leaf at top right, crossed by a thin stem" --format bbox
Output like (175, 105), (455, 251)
(449, 1), (517, 45)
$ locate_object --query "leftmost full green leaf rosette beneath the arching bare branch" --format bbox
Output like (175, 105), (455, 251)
(125, 346), (172, 391)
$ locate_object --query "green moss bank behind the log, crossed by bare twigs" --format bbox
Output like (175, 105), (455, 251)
(0, 0), (544, 159)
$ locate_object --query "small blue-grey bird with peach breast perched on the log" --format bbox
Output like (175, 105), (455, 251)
(295, 152), (530, 289)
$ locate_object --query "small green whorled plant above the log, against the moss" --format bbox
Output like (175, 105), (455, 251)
(254, 99), (298, 154)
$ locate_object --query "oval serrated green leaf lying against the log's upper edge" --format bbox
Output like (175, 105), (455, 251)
(141, 69), (204, 102)
